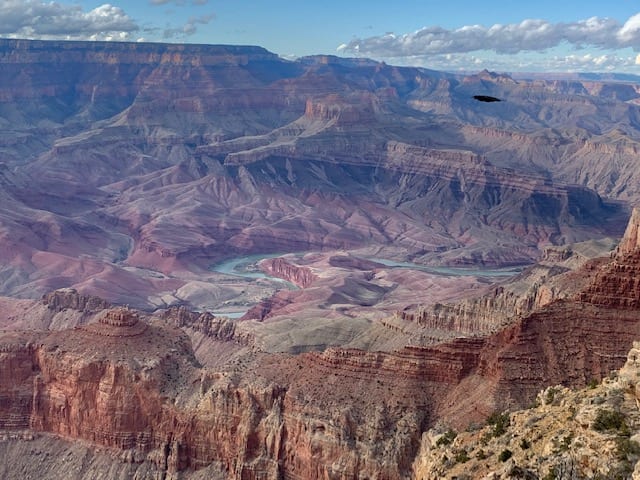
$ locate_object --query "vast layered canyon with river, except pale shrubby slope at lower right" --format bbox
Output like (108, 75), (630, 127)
(0, 39), (640, 480)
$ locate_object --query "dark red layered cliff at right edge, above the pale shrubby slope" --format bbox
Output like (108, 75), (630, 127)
(438, 211), (640, 418)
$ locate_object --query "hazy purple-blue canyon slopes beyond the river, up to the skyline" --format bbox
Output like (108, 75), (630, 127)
(0, 40), (640, 308)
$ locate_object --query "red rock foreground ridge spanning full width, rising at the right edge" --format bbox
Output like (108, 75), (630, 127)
(0, 212), (640, 480)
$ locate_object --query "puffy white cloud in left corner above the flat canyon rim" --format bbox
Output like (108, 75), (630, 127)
(0, 0), (140, 40)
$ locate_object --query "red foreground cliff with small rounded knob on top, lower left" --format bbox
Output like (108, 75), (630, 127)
(0, 309), (450, 480)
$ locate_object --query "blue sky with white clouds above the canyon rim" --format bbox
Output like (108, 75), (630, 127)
(0, 0), (640, 74)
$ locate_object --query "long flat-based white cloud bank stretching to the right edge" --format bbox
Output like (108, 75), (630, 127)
(338, 13), (640, 58)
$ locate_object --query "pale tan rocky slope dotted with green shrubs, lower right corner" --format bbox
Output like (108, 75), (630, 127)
(413, 348), (640, 480)
